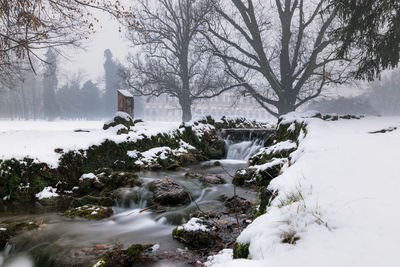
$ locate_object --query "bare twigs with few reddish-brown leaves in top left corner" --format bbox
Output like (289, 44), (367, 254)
(0, 0), (136, 88)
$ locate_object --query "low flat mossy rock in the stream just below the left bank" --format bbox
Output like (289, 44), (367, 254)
(64, 204), (113, 220)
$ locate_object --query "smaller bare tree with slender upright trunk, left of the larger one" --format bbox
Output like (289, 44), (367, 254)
(125, 0), (237, 121)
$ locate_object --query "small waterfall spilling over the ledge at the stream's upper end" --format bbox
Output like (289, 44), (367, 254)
(226, 139), (264, 160)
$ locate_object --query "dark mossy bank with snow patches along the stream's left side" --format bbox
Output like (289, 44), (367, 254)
(0, 114), (231, 208)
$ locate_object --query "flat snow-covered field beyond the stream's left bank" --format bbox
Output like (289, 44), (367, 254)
(0, 121), (179, 166)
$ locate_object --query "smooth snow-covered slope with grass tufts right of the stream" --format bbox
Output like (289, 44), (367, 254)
(209, 117), (400, 267)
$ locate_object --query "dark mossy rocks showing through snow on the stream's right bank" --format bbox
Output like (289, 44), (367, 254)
(220, 112), (362, 260)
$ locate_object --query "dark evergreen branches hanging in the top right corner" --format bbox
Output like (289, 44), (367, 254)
(332, 0), (400, 80)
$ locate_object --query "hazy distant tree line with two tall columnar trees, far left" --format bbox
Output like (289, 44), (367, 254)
(0, 49), (121, 120)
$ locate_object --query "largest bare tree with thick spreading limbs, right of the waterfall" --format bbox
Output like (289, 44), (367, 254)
(207, 0), (350, 116)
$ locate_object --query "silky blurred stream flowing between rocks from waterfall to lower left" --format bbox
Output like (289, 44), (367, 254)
(0, 141), (261, 267)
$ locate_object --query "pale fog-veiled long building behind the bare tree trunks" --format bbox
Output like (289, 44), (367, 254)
(139, 92), (271, 121)
